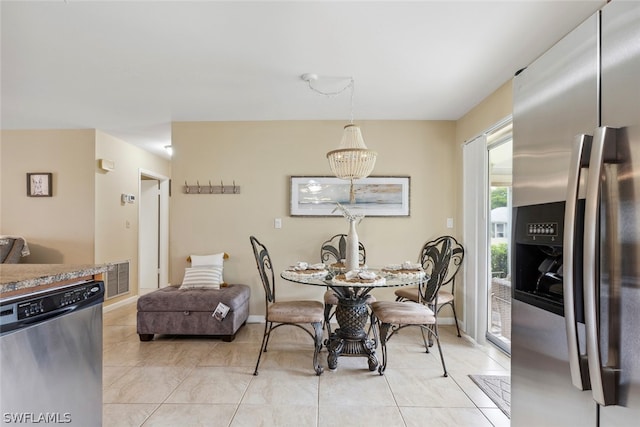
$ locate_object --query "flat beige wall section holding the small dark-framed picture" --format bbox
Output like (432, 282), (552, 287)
(0, 130), (95, 264)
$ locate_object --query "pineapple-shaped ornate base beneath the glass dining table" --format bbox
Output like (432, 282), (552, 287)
(326, 295), (378, 371)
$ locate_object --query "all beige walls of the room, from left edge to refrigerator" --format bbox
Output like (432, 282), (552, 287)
(0, 82), (511, 316)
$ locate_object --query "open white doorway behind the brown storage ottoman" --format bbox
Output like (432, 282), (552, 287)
(138, 170), (169, 294)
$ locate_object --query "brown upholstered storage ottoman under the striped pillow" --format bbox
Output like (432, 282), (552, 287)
(137, 285), (251, 342)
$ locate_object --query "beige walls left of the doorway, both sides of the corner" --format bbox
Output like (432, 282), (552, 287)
(0, 130), (171, 303)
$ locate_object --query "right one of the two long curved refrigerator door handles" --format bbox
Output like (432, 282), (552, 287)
(583, 127), (617, 406)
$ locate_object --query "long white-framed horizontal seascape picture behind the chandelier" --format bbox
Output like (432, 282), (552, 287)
(290, 176), (411, 217)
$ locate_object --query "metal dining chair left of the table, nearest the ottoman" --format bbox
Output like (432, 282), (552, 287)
(249, 236), (324, 375)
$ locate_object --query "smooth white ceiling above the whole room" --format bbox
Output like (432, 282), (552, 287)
(0, 0), (604, 156)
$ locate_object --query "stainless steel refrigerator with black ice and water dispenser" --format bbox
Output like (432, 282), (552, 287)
(511, 0), (640, 427)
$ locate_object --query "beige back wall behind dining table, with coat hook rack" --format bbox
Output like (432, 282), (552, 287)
(170, 121), (458, 315)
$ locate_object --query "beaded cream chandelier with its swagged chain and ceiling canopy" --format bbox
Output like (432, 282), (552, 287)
(302, 73), (378, 203)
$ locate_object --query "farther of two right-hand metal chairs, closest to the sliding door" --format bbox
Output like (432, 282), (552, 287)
(395, 236), (464, 336)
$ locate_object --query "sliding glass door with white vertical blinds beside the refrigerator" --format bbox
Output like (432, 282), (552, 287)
(463, 117), (512, 354)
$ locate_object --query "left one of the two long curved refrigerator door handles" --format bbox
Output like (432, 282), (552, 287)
(562, 135), (593, 390)
